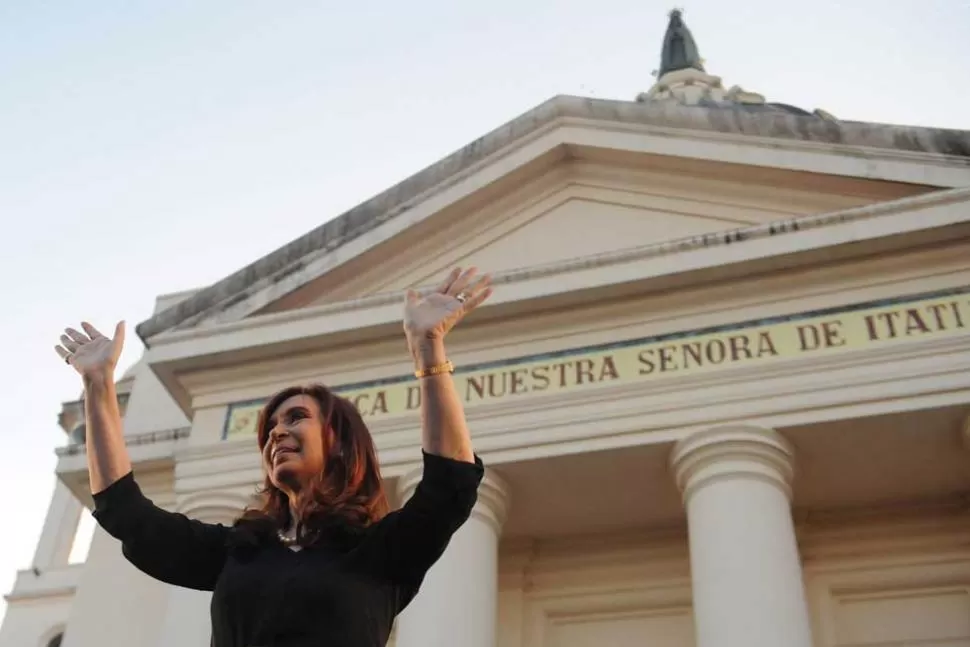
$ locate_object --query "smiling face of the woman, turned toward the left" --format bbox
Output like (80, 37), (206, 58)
(263, 395), (326, 491)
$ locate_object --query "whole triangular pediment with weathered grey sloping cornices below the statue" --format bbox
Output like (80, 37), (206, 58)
(138, 97), (967, 345)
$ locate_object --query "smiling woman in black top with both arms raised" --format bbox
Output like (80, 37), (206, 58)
(56, 269), (491, 647)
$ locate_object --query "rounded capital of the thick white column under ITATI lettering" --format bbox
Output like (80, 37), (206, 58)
(670, 424), (795, 502)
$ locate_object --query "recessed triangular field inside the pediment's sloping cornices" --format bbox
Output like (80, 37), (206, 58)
(262, 158), (932, 312)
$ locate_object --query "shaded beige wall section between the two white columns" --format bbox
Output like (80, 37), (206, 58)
(498, 532), (694, 647)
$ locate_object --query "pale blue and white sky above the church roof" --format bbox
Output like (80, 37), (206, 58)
(0, 0), (970, 628)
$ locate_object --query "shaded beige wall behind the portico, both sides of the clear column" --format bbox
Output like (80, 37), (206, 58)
(498, 510), (970, 647)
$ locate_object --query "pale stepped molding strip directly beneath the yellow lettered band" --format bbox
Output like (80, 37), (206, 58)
(166, 334), (970, 480)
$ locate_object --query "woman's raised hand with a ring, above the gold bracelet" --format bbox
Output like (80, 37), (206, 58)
(404, 267), (492, 353)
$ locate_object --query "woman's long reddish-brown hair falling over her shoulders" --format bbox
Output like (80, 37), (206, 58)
(237, 384), (389, 544)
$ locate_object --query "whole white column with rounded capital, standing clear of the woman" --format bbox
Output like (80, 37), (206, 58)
(670, 425), (812, 647)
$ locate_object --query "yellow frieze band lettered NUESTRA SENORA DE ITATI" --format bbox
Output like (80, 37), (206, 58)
(225, 290), (970, 437)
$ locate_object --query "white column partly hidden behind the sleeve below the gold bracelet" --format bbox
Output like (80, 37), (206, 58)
(394, 469), (509, 647)
